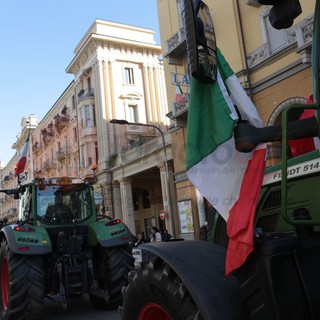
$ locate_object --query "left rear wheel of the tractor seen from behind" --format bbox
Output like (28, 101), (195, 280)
(0, 240), (45, 320)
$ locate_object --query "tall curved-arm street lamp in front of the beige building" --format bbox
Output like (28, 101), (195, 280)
(110, 119), (176, 238)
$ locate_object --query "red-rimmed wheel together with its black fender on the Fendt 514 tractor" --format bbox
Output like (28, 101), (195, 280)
(119, 241), (249, 320)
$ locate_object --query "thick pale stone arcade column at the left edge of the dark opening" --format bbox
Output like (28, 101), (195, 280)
(119, 178), (136, 235)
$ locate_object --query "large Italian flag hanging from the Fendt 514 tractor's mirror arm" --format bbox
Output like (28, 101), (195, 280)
(186, 50), (266, 275)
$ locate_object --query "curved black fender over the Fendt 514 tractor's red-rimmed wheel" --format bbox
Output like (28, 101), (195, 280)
(139, 240), (248, 320)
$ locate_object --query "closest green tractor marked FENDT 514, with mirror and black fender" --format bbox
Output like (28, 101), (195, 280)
(120, 0), (320, 320)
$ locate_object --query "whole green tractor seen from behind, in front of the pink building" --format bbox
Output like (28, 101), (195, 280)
(0, 175), (134, 320)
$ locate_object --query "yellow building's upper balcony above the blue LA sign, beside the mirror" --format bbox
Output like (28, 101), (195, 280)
(164, 27), (187, 65)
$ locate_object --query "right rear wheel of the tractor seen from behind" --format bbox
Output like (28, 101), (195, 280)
(90, 245), (134, 310)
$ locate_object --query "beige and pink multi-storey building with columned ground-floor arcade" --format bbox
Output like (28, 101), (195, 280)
(3, 20), (174, 233)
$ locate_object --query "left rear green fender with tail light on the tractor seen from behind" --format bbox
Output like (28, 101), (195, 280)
(0, 225), (52, 255)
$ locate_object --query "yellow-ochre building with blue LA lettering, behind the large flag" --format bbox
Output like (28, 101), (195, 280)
(157, 0), (315, 239)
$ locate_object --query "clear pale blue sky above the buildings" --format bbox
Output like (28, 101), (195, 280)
(0, 0), (160, 164)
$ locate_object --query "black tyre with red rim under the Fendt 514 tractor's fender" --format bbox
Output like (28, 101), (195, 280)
(119, 257), (203, 320)
